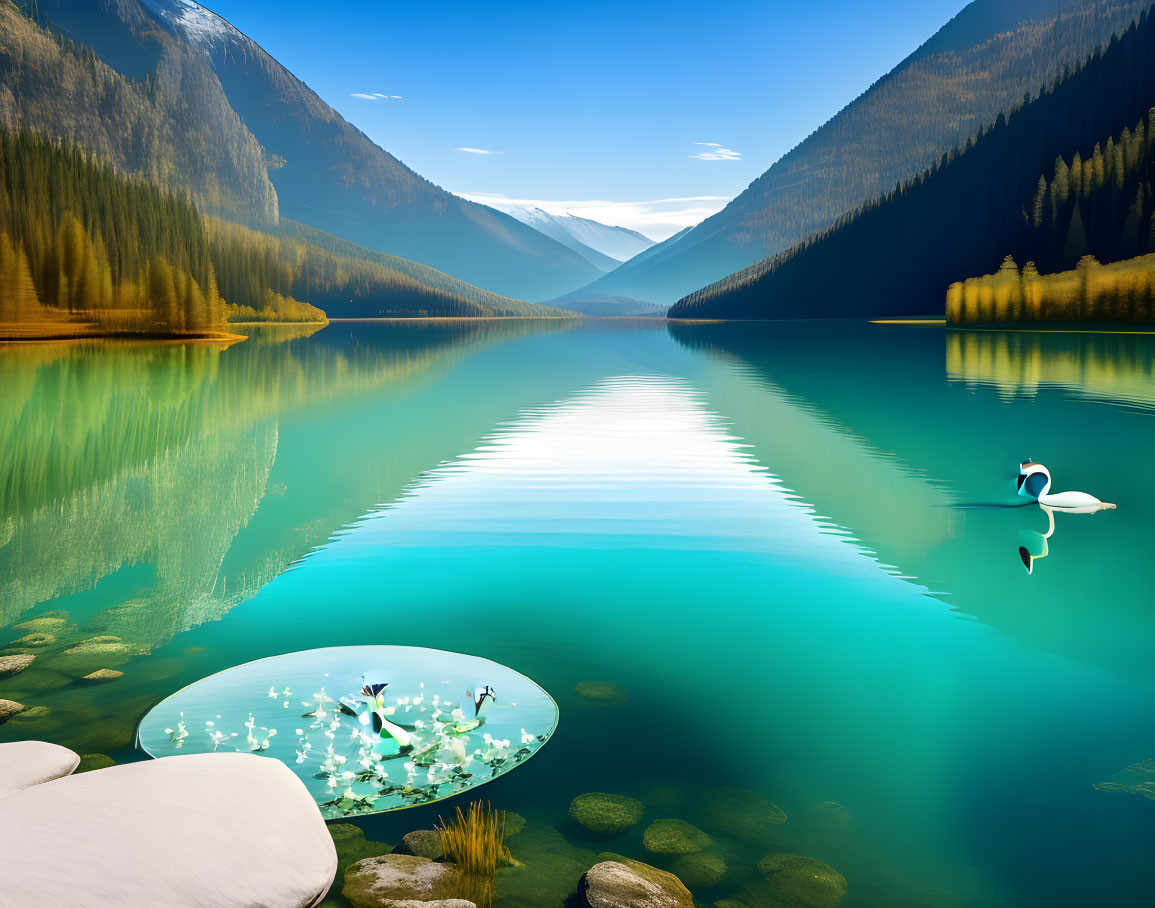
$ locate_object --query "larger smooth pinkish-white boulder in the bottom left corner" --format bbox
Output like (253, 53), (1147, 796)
(0, 753), (337, 908)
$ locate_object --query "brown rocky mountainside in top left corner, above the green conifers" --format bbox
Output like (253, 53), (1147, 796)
(0, 0), (277, 224)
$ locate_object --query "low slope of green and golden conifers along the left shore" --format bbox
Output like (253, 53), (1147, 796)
(0, 132), (571, 337)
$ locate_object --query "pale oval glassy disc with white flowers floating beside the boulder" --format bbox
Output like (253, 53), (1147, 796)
(140, 646), (558, 817)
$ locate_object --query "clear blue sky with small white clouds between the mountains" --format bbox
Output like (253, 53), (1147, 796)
(206, 0), (966, 238)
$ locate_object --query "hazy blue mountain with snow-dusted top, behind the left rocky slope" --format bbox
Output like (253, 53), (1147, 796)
(142, 0), (597, 299)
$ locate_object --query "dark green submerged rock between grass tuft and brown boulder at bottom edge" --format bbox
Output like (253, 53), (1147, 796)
(493, 823), (598, 908)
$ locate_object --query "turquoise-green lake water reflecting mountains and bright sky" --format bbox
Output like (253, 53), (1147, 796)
(0, 321), (1155, 906)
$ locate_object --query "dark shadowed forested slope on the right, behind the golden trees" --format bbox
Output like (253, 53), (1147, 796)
(670, 14), (1155, 319)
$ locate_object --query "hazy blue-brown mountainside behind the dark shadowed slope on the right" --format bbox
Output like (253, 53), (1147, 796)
(567, 0), (1149, 303)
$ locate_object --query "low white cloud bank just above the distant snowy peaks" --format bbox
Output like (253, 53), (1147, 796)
(457, 193), (730, 240)
